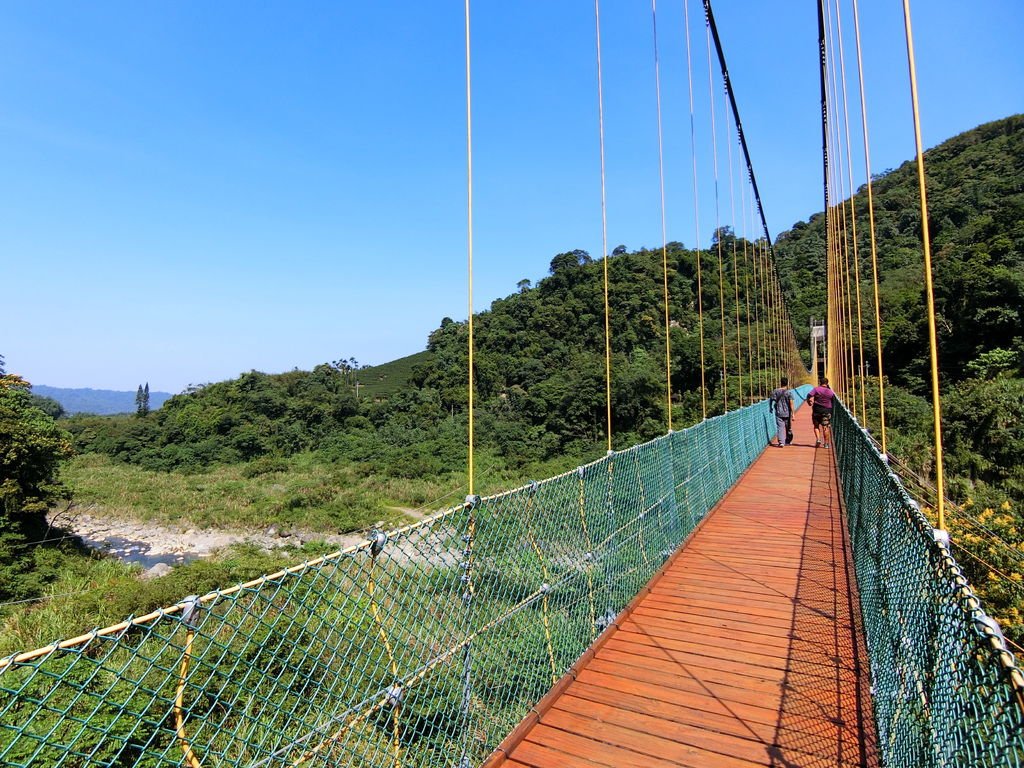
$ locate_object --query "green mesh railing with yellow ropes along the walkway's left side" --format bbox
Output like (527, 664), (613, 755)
(0, 402), (790, 768)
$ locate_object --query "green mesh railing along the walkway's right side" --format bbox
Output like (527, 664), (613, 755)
(833, 404), (1024, 768)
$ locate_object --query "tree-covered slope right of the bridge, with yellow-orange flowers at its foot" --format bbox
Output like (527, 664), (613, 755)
(775, 115), (1024, 642)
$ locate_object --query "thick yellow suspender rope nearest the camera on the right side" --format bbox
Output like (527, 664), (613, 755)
(903, 0), (946, 530)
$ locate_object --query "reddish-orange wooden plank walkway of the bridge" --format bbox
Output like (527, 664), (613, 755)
(488, 408), (878, 768)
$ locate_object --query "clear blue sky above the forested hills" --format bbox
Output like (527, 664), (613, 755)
(0, 0), (1024, 392)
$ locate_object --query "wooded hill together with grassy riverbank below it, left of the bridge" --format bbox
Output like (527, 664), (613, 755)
(0, 229), (798, 648)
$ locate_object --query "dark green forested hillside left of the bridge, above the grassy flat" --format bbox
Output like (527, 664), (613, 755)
(68, 239), (790, 477)
